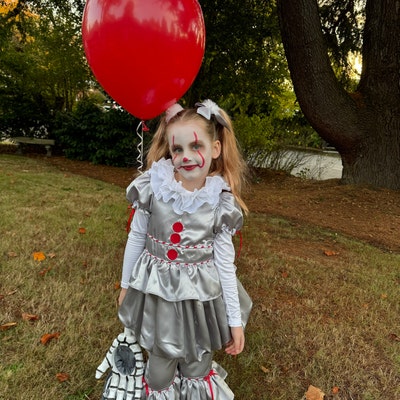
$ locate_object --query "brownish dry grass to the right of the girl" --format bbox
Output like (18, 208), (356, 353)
(223, 215), (400, 400)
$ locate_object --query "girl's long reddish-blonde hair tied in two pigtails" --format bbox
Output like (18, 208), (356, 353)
(146, 108), (248, 213)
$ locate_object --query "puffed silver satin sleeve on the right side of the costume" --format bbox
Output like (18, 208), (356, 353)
(214, 192), (243, 235)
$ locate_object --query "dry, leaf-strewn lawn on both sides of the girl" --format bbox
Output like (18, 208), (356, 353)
(0, 155), (400, 400)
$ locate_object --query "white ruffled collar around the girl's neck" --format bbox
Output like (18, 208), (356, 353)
(149, 158), (230, 215)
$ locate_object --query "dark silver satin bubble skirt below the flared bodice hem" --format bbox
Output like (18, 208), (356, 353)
(119, 287), (231, 362)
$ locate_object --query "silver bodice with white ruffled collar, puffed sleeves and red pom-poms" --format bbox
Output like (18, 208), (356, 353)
(127, 160), (242, 301)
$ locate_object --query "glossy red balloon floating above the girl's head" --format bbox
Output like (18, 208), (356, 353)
(82, 0), (205, 120)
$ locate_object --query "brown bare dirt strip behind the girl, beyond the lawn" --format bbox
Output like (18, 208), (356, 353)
(18, 155), (400, 252)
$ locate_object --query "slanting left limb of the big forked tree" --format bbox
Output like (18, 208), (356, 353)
(278, 0), (361, 150)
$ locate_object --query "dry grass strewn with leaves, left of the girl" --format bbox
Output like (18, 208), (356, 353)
(0, 156), (126, 400)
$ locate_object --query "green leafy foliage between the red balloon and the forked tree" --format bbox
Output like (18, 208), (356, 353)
(183, 0), (321, 159)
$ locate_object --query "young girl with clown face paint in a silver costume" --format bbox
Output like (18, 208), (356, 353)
(119, 100), (249, 400)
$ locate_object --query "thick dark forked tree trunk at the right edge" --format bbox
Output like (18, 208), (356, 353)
(278, 0), (400, 189)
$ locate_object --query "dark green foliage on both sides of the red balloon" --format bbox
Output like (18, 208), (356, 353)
(0, 0), (324, 160)
